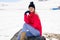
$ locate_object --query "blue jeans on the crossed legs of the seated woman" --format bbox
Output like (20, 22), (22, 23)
(18, 23), (40, 40)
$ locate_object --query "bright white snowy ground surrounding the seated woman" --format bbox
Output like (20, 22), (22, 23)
(0, 0), (60, 40)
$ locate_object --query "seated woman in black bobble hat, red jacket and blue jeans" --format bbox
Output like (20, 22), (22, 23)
(18, 2), (42, 40)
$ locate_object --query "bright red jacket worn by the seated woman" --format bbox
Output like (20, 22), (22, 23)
(24, 12), (42, 36)
